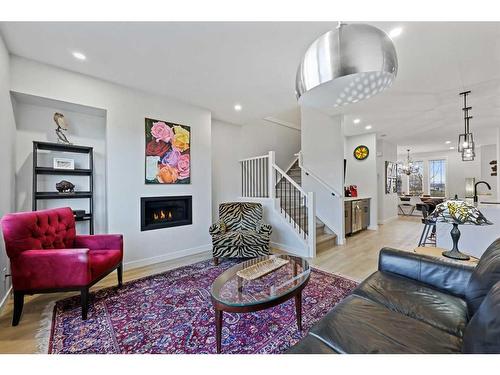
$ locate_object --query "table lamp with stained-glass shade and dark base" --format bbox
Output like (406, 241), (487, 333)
(430, 196), (493, 260)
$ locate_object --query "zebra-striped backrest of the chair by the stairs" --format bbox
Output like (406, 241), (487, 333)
(219, 202), (263, 231)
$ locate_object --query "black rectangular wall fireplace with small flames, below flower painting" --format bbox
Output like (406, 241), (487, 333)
(141, 195), (193, 231)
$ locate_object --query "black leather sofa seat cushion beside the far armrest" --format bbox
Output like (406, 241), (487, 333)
(353, 271), (467, 337)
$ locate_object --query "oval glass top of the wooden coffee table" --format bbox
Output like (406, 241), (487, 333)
(210, 255), (311, 306)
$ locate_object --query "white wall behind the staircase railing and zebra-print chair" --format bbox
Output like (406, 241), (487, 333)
(212, 120), (300, 220)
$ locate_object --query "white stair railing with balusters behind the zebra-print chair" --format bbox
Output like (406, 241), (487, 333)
(240, 151), (316, 257)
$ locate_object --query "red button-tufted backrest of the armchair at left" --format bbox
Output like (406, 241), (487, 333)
(2, 207), (76, 258)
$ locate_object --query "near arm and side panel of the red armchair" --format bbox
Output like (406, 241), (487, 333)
(11, 249), (91, 290)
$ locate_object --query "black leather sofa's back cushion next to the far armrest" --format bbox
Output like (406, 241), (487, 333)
(465, 238), (500, 317)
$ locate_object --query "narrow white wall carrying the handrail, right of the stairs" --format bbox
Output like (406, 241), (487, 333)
(301, 107), (344, 244)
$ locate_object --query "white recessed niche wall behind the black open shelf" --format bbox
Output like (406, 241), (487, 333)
(13, 94), (107, 234)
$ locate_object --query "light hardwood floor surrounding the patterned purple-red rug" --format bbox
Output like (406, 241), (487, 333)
(0, 217), (422, 353)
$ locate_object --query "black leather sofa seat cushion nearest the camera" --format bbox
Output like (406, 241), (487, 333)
(309, 295), (462, 354)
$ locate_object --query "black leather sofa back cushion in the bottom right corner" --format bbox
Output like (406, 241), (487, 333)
(463, 282), (500, 353)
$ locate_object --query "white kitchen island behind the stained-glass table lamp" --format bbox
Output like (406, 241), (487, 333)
(436, 198), (500, 258)
